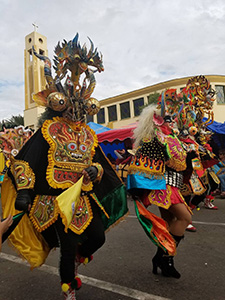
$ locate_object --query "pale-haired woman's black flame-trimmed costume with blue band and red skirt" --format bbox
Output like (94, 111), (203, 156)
(128, 126), (191, 214)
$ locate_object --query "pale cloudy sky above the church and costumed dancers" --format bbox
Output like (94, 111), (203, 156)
(0, 0), (225, 120)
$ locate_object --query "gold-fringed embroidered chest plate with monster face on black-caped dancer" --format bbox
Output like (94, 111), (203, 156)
(42, 118), (97, 189)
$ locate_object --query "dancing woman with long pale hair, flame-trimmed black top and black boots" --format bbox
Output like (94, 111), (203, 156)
(127, 97), (191, 278)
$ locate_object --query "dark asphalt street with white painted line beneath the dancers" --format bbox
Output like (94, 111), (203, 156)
(0, 199), (225, 300)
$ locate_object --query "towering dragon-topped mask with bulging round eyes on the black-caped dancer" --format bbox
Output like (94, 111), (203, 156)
(33, 34), (104, 122)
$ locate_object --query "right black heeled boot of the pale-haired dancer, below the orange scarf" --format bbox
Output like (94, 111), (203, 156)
(161, 234), (184, 278)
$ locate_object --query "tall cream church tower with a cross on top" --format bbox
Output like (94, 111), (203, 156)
(24, 25), (48, 130)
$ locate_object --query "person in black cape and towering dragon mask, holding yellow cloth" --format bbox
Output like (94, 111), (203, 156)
(2, 34), (127, 300)
